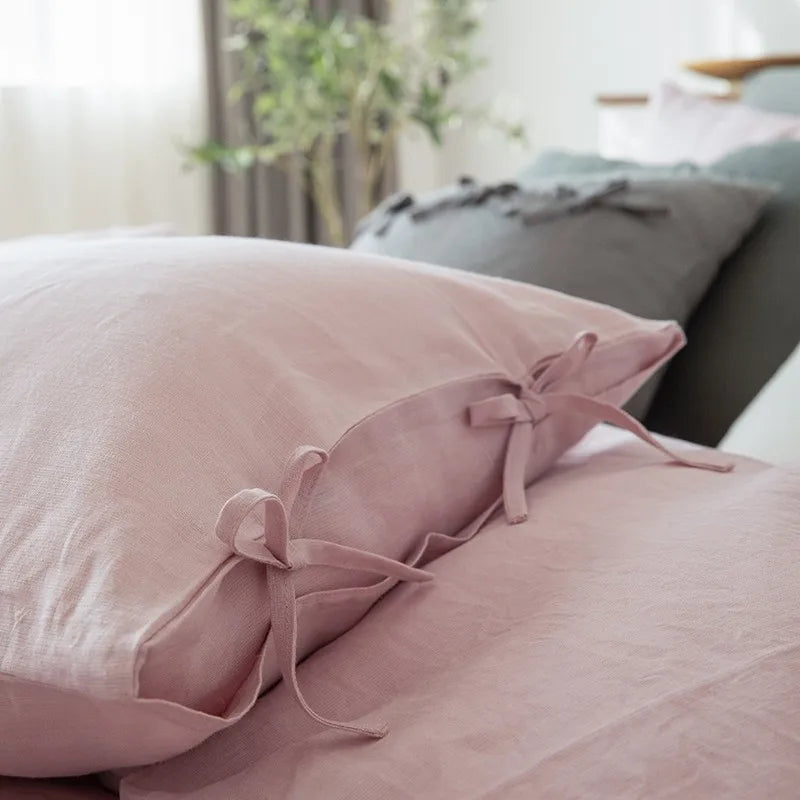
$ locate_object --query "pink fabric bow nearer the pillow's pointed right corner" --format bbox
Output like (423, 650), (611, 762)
(469, 333), (733, 525)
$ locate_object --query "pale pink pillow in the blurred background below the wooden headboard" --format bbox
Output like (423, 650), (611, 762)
(641, 83), (800, 164)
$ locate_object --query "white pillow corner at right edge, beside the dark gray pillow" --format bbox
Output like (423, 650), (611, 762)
(719, 346), (800, 464)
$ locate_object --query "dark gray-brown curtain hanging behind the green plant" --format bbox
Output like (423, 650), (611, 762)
(202, 0), (394, 244)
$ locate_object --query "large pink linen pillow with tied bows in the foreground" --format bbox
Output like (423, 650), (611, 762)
(0, 238), (683, 776)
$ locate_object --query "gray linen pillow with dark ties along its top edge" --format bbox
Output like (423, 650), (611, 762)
(351, 172), (771, 416)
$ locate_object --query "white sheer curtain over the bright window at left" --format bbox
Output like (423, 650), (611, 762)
(0, 0), (209, 238)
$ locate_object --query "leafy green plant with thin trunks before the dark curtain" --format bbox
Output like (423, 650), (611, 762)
(191, 0), (523, 245)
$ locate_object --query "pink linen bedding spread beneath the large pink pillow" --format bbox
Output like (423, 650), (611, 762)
(121, 428), (800, 800)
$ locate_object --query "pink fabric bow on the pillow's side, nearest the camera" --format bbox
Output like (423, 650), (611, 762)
(216, 447), (433, 739)
